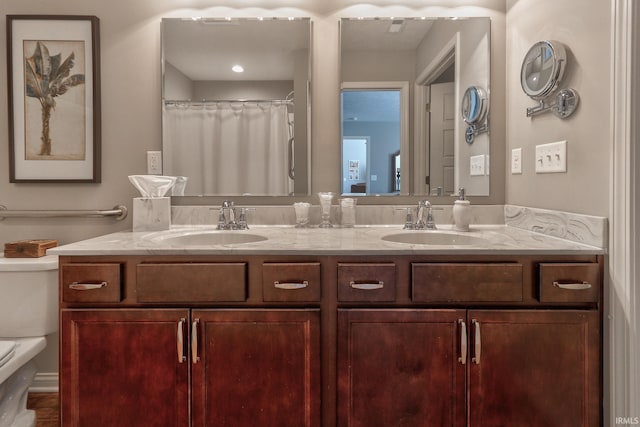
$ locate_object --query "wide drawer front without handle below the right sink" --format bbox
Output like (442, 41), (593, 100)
(411, 263), (523, 302)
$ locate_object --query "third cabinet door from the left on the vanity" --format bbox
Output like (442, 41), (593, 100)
(338, 309), (467, 427)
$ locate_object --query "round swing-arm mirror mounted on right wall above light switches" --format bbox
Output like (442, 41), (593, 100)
(520, 40), (580, 119)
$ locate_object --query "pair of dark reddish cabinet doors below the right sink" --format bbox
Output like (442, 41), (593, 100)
(338, 309), (600, 427)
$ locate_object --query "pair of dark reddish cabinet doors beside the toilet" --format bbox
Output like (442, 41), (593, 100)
(61, 309), (320, 427)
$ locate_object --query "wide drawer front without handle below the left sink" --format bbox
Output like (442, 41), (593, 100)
(136, 262), (247, 303)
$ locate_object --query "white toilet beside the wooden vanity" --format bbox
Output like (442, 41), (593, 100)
(0, 255), (58, 427)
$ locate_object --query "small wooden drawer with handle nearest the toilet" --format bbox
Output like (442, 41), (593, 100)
(61, 263), (122, 302)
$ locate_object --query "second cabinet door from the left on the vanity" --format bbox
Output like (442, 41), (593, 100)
(192, 309), (320, 427)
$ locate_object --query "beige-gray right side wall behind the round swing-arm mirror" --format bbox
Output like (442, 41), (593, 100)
(506, 0), (612, 216)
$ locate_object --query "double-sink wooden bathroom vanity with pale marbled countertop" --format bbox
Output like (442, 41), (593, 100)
(56, 226), (604, 427)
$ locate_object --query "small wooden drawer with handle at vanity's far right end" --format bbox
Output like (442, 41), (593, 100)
(538, 263), (601, 302)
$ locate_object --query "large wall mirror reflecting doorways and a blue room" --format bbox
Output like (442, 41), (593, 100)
(340, 18), (491, 196)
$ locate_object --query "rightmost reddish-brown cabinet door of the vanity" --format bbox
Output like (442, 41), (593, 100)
(468, 310), (600, 427)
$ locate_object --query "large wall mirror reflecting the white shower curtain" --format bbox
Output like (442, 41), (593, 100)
(161, 18), (311, 196)
